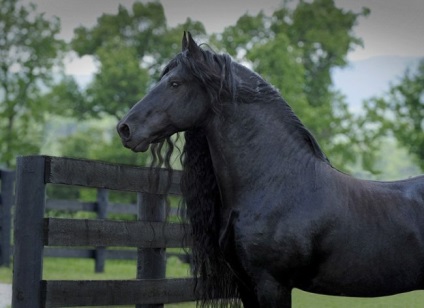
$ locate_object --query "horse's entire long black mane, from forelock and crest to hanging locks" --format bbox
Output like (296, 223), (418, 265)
(151, 45), (327, 307)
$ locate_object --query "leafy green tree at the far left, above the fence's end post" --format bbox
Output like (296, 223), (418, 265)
(0, 0), (64, 167)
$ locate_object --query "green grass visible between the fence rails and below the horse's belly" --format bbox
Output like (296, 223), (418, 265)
(0, 258), (424, 308)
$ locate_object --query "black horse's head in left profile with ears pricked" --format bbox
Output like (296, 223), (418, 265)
(117, 32), (214, 152)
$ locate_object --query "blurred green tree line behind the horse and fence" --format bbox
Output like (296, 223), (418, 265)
(0, 0), (424, 171)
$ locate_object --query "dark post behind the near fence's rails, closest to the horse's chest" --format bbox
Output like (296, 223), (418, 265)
(136, 193), (166, 308)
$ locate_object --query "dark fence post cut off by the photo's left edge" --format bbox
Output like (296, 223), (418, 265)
(0, 170), (15, 267)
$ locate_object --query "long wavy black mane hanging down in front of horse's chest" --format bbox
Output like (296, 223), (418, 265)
(181, 130), (239, 307)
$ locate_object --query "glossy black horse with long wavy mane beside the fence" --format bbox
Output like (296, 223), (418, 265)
(117, 33), (424, 307)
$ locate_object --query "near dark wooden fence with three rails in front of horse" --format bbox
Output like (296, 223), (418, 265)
(12, 156), (196, 308)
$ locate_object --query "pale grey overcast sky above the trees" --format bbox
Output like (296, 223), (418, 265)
(30, 0), (424, 74)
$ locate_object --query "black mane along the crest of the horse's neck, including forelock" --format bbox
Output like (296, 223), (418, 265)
(168, 46), (330, 163)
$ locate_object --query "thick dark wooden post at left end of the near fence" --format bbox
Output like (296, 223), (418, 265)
(12, 156), (45, 308)
